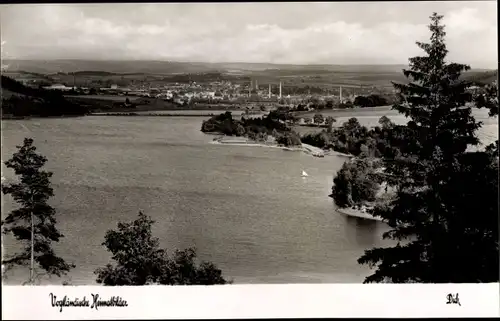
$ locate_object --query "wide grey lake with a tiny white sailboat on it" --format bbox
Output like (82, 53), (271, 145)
(2, 109), (498, 285)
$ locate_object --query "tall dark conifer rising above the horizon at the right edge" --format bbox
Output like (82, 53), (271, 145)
(358, 13), (499, 283)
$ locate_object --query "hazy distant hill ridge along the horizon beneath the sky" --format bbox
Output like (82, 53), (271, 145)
(2, 59), (498, 87)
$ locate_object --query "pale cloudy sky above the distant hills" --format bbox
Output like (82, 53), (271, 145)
(0, 1), (498, 69)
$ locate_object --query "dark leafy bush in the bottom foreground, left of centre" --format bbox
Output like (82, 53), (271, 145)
(94, 212), (231, 285)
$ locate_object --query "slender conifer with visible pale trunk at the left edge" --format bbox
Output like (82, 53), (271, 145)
(2, 138), (74, 284)
